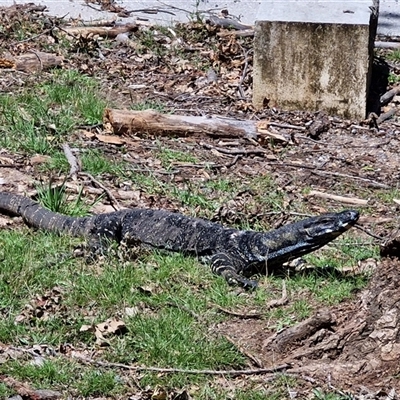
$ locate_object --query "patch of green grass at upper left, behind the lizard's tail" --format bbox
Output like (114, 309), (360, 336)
(0, 71), (106, 155)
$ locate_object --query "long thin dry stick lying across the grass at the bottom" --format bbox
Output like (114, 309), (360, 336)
(74, 357), (290, 376)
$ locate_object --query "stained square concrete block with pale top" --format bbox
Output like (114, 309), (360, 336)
(253, 0), (378, 119)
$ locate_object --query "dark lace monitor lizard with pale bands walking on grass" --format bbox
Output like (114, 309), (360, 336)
(0, 192), (359, 288)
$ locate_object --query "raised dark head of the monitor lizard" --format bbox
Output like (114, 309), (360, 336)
(302, 210), (360, 245)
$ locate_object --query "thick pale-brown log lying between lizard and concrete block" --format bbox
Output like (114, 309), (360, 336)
(103, 109), (257, 139)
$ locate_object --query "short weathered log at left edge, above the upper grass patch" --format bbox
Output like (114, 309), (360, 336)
(0, 51), (64, 73)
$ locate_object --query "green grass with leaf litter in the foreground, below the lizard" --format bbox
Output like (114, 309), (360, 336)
(0, 217), (367, 399)
